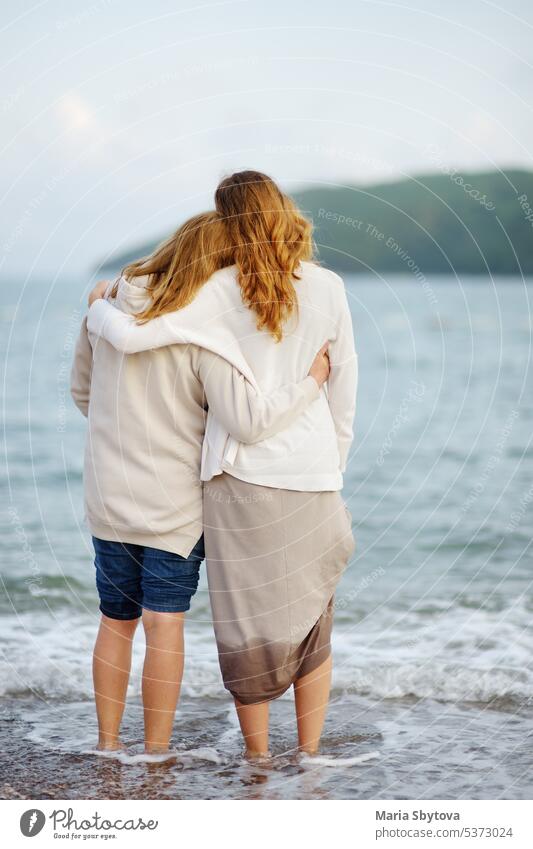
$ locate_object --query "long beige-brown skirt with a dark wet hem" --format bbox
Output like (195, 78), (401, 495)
(204, 474), (355, 704)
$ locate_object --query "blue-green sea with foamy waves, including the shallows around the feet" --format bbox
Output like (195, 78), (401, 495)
(0, 277), (533, 799)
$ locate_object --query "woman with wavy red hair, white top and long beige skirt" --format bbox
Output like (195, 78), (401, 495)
(88, 171), (357, 757)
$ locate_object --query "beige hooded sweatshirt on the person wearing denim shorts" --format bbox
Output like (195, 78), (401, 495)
(71, 279), (319, 557)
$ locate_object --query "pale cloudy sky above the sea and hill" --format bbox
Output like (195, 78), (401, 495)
(0, 0), (533, 280)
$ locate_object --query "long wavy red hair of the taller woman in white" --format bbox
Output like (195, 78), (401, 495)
(215, 171), (313, 341)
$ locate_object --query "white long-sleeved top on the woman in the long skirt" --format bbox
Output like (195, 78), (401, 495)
(88, 262), (358, 491)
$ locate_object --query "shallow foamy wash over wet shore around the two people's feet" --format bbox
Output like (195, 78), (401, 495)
(0, 695), (533, 799)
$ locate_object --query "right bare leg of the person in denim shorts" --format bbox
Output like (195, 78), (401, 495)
(142, 610), (185, 754)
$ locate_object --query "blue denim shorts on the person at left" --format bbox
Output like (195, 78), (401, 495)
(93, 536), (204, 619)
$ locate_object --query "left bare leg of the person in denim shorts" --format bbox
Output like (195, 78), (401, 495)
(93, 615), (139, 751)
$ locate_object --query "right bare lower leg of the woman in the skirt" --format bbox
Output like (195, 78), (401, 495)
(294, 655), (331, 755)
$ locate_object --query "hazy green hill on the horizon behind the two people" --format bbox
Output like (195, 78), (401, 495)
(97, 171), (533, 275)
